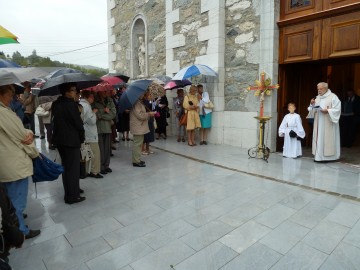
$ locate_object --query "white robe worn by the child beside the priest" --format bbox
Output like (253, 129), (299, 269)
(279, 113), (305, 158)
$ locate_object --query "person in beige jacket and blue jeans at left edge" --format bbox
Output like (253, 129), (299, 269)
(0, 85), (40, 239)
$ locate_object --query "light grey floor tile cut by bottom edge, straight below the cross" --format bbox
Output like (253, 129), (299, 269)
(221, 243), (281, 270)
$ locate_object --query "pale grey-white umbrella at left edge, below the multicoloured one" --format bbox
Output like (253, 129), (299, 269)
(0, 67), (49, 85)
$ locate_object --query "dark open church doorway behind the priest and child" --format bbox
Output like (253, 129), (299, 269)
(276, 57), (360, 165)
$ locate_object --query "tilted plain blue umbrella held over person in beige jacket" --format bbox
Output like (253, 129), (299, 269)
(119, 80), (152, 113)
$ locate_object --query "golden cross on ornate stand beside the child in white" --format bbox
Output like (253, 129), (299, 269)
(247, 72), (279, 162)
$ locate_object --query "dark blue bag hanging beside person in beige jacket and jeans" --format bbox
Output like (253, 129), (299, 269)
(32, 153), (64, 183)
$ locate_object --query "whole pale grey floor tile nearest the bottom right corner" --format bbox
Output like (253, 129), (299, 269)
(303, 220), (350, 254)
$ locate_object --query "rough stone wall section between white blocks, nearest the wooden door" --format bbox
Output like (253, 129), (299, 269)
(224, 0), (260, 112)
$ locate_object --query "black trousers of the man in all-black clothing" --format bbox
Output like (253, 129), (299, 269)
(58, 145), (80, 200)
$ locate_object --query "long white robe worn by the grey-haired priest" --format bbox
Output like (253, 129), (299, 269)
(308, 89), (341, 161)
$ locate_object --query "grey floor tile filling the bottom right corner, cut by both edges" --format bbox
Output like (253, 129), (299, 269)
(320, 243), (360, 270)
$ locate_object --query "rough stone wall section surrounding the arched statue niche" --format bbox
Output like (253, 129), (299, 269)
(110, 0), (166, 77)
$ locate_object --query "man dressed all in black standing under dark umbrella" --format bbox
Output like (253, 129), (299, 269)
(52, 83), (85, 204)
